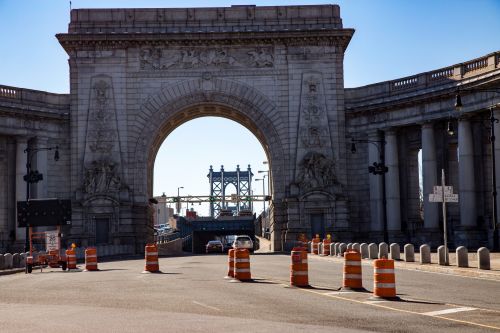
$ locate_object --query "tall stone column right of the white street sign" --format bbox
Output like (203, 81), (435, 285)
(458, 119), (477, 226)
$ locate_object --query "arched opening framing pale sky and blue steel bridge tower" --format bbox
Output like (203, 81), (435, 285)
(153, 116), (270, 252)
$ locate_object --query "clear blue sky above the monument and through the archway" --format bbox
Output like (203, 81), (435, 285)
(0, 0), (500, 212)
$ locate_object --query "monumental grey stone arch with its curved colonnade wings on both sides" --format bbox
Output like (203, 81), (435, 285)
(0, 5), (500, 251)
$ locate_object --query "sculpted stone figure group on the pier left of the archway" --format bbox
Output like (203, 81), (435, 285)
(83, 160), (122, 195)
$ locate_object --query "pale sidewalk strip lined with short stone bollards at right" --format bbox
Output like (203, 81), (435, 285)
(316, 252), (500, 282)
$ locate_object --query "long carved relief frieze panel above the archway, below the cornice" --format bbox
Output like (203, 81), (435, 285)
(139, 47), (274, 70)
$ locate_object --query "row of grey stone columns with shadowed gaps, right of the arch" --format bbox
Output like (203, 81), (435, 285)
(368, 114), (500, 246)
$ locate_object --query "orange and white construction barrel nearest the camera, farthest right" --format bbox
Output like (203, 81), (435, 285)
(373, 259), (396, 298)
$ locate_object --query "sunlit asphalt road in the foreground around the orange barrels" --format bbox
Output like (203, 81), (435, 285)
(0, 255), (500, 333)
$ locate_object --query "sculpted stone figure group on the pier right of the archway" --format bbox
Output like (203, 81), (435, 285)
(297, 152), (336, 191)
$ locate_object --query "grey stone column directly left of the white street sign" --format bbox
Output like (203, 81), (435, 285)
(422, 123), (439, 229)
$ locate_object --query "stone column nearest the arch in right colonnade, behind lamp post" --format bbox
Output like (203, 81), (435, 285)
(367, 132), (384, 231)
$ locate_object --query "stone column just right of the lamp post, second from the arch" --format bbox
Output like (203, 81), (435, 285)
(385, 131), (401, 231)
